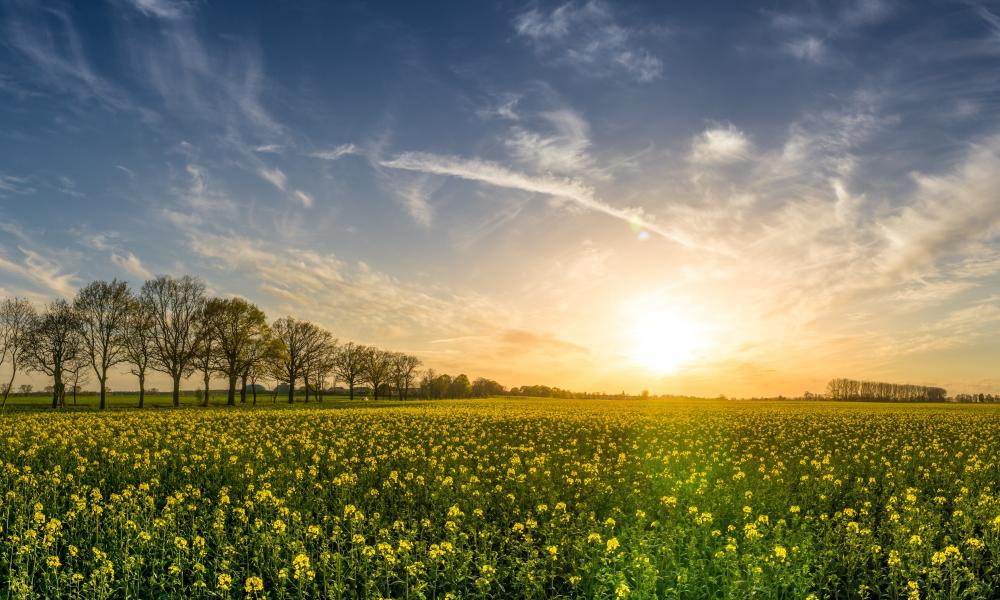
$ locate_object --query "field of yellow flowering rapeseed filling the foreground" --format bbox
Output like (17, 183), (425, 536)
(0, 398), (1000, 599)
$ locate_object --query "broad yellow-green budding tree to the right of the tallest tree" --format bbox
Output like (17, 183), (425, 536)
(206, 298), (268, 406)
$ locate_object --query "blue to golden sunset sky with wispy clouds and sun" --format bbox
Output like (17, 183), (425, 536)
(0, 0), (1000, 396)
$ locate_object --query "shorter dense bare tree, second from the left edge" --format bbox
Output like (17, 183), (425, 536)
(28, 300), (83, 408)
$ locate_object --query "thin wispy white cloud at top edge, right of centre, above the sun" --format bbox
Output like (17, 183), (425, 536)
(514, 0), (663, 82)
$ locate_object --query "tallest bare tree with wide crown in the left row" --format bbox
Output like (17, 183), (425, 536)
(139, 275), (205, 407)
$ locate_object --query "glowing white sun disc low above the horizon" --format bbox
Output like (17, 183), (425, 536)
(628, 309), (706, 375)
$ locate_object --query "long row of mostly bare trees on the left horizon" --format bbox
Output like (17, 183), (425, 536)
(0, 276), (434, 410)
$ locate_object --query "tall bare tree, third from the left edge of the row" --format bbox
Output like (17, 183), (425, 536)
(73, 279), (131, 410)
